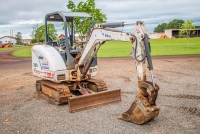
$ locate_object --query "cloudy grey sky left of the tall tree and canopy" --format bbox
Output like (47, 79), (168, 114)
(0, 0), (67, 38)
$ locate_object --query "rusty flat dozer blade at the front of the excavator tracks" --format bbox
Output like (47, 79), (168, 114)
(68, 89), (121, 112)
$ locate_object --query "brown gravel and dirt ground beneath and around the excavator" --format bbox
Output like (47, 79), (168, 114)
(0, 57), (200, 134)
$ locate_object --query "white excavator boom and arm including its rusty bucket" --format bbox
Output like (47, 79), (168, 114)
(76, 21), (159, 124)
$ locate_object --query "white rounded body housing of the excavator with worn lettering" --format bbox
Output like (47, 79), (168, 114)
(32, 45), (98, 83)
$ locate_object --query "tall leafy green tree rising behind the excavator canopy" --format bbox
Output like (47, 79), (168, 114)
(67, 0), (107, 40)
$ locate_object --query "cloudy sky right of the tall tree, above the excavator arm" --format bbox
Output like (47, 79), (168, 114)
(96, 0), (200, 32)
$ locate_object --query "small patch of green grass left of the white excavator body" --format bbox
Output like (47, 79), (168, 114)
(12, 47), (31, 58)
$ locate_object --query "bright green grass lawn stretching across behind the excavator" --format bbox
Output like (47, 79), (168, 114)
(9, 38), (200, 58)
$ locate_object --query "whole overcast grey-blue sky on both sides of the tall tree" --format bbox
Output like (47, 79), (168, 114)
(0, 0), (200, 39)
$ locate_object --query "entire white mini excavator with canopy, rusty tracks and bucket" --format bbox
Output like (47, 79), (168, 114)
(32, 11), (159, 124)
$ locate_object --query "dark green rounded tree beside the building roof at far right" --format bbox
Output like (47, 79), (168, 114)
(154, 19), (184, 33)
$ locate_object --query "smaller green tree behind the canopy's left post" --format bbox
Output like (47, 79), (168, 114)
(31, 23), (58, 43)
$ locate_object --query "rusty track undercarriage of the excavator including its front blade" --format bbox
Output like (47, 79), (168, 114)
(36, 79), (121, 112)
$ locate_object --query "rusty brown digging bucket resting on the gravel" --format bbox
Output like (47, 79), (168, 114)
(118, 82), (159, 124)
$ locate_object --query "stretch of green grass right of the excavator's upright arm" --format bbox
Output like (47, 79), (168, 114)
(150, 38), (200, 56)
